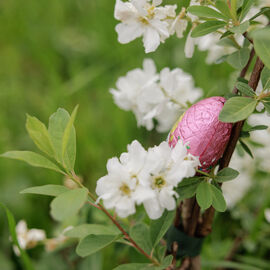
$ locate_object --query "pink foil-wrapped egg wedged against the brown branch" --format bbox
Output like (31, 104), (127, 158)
(168, 97), (232, 171)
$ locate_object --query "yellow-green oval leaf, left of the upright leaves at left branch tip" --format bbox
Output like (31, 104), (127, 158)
(26, 114), (54, 157)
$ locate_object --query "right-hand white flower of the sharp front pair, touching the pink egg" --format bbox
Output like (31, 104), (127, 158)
(142, 141), (199, 219)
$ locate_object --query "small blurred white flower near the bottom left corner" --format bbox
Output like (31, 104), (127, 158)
(13, 220), (46, 256)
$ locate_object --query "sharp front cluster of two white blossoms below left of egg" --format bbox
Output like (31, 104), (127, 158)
(96, 141), (200, 219)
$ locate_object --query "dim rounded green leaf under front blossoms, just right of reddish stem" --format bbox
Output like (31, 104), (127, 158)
(130, 223), (152, 254)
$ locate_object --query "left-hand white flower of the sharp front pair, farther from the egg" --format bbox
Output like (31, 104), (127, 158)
(96, 141), (154, 218)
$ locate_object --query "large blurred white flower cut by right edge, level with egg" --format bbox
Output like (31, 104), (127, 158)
(248, 112), (270, 172)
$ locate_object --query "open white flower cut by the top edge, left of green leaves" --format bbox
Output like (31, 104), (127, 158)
(114, 0), (173, 53)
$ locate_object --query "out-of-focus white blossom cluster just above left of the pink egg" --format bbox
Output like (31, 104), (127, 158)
(110, 59), (202, 132)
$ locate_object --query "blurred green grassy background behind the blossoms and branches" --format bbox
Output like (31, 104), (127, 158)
(0, 0), (270, 270)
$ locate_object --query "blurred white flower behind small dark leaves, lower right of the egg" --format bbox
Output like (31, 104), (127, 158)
(222, 151), (254, 208)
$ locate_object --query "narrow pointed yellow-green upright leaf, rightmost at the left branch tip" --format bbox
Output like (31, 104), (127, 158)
(62, 105), (79, 170)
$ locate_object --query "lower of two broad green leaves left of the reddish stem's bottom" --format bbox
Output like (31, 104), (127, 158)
(76, 234), (120, 257)
